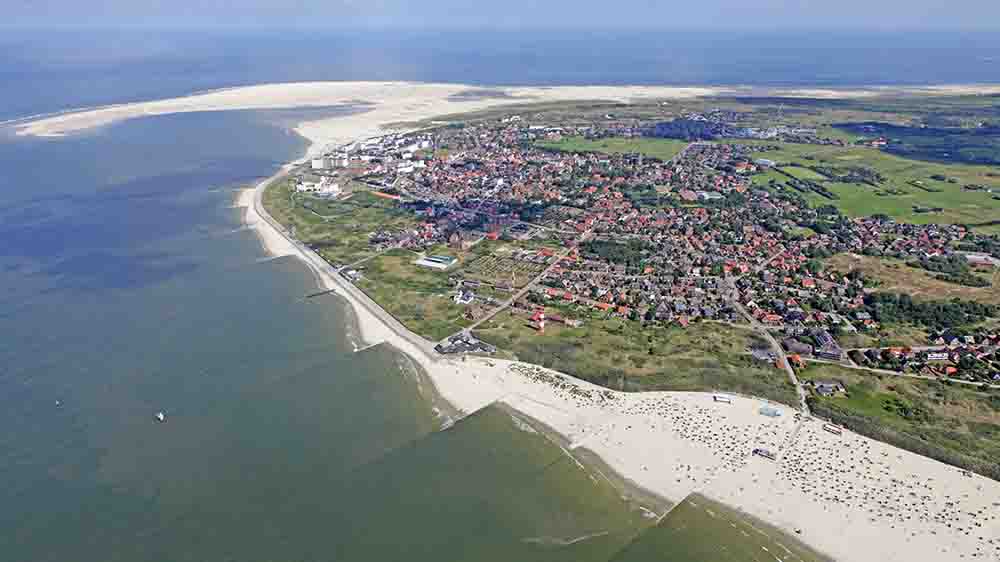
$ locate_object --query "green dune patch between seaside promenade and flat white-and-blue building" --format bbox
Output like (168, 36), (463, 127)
(357, 248), (468, 341)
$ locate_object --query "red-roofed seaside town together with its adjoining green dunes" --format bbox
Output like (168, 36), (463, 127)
(264, 99), (1000, 476)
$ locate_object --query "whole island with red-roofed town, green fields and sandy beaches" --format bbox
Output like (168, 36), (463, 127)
(19, 83), (1000, 561)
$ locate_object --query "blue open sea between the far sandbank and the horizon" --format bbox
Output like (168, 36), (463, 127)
(0, 29), (1000, 120)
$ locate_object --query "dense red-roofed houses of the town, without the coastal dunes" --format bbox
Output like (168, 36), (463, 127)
(286, 113), (1000, 383)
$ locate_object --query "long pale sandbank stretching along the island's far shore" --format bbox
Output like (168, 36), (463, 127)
(13, 81), (1000, 147)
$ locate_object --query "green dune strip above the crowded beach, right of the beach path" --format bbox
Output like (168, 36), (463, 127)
(799, 363), (1000, 479)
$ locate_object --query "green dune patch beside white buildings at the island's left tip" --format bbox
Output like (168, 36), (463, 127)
(264, 182), (417, 264)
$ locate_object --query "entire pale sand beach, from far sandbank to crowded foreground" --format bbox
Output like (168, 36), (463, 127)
(19, 83), (1000, 562)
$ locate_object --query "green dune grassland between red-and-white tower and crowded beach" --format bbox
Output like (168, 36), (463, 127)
(476, 310), (796, 404)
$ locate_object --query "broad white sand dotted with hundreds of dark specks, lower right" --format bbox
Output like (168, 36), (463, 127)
(504, 356), (1000, 560)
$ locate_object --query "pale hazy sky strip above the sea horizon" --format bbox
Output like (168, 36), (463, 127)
(7, 0), (1000, 30)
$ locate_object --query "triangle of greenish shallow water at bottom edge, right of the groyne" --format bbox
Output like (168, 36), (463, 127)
(611, 494), (833, 562)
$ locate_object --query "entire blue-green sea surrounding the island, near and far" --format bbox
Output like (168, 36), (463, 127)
(0, 29), (1000, 562)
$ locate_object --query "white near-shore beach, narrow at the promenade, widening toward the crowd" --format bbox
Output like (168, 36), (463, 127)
(236, 133), (1000, 562)
